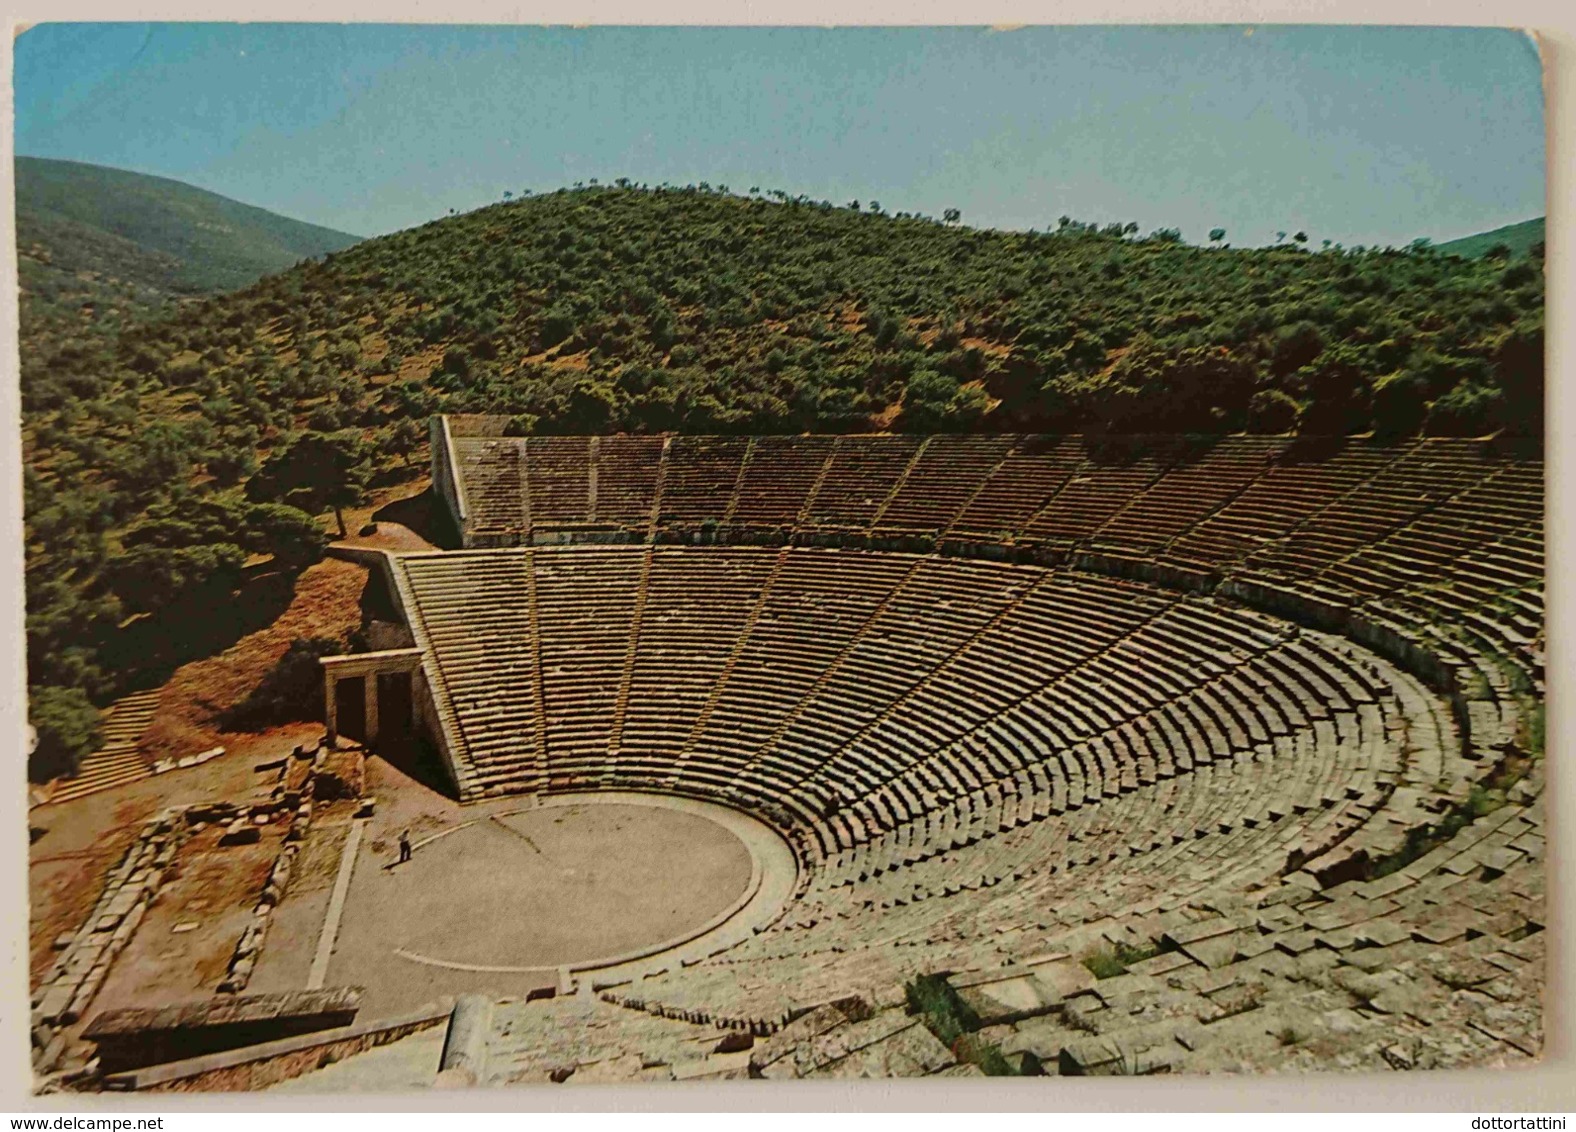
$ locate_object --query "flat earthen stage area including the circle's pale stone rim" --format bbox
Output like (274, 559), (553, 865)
(327, 791), (799, 1017)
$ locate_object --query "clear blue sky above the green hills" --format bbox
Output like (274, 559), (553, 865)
(16, 24), (1544, 244)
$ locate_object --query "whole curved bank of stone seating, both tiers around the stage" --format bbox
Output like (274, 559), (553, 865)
(409, 418), (1543, 1065)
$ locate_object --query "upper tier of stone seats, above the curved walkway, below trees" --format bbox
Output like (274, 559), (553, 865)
(435, 416), (1543, 675)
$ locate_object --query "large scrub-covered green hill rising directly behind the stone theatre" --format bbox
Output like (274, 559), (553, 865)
(24, 184), (1543, 772)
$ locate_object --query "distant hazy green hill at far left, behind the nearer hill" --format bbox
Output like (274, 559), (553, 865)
(16, 158), (359, 345)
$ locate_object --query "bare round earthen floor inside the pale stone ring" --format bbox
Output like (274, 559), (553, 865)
(389, 802), (752, 968)
